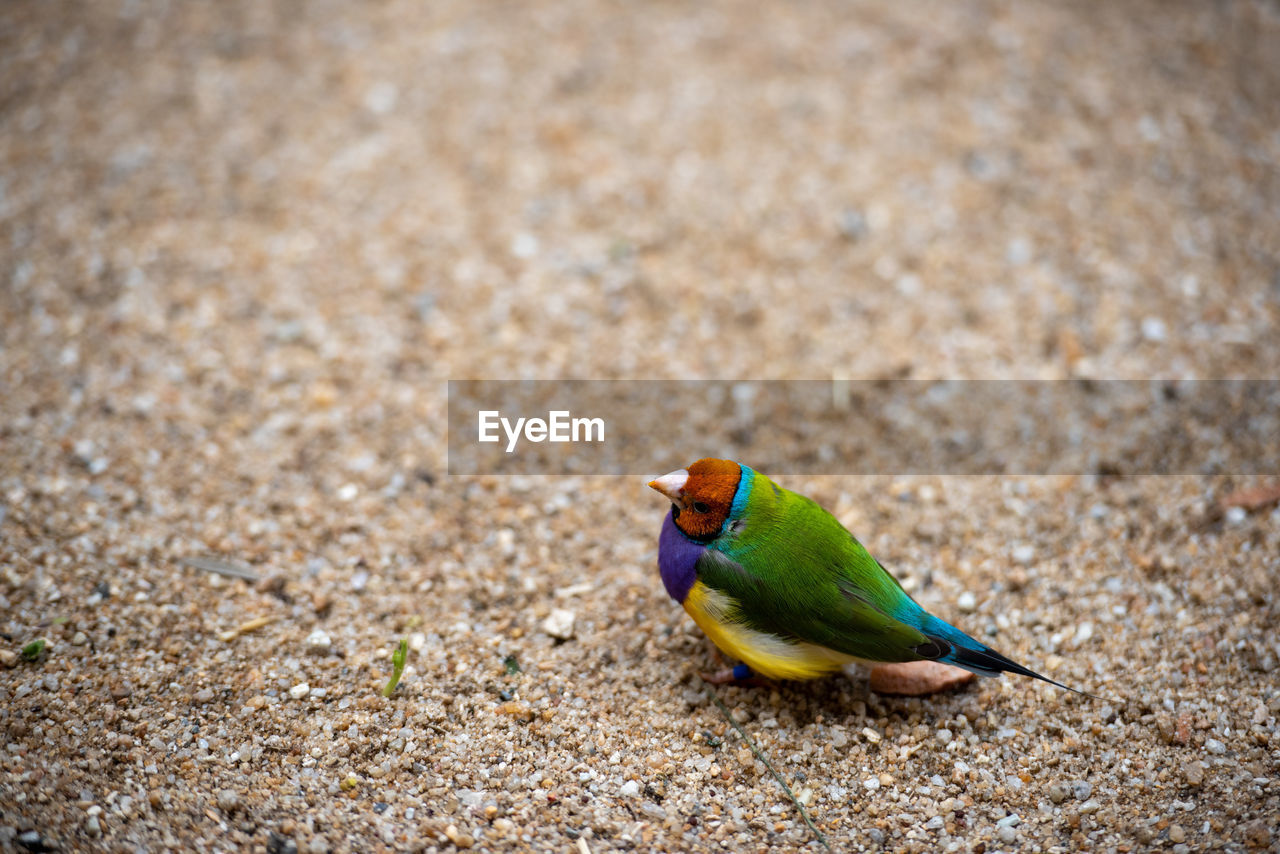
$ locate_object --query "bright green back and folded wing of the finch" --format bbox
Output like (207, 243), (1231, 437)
(698, 475), (929, 661)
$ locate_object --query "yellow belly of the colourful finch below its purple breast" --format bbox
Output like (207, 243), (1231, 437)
(685, 581), (854, 679)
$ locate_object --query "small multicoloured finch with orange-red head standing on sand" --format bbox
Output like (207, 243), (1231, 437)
(649, 458), (1080, 693)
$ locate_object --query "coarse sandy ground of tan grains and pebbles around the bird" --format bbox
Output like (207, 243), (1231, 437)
(0, 0), (1280, 851)
